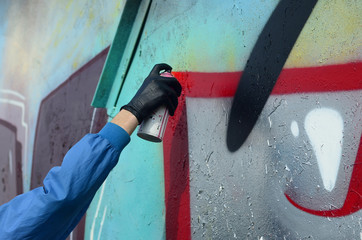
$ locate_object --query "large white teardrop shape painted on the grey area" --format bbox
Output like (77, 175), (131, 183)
(304, 108), (343, 191)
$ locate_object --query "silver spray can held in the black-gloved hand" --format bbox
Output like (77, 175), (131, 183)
(137, 71), (173, 142)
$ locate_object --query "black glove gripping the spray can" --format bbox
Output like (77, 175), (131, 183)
(122, 63), (182, 124)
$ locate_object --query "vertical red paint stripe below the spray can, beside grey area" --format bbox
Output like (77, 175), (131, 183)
(163, 95), (191, 240)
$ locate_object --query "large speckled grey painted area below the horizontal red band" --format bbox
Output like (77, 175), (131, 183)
(186, 91), (362, 240)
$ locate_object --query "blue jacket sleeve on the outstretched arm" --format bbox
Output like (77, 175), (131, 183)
(0, 123), (130, 240)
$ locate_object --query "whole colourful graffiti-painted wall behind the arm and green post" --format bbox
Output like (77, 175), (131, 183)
(0, 0), (362, 239)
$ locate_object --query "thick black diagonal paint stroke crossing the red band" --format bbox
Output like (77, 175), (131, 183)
(227, 0), (318, 152)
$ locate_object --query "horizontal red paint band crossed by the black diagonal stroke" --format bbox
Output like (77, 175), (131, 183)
(173, 62), (362, 98)
